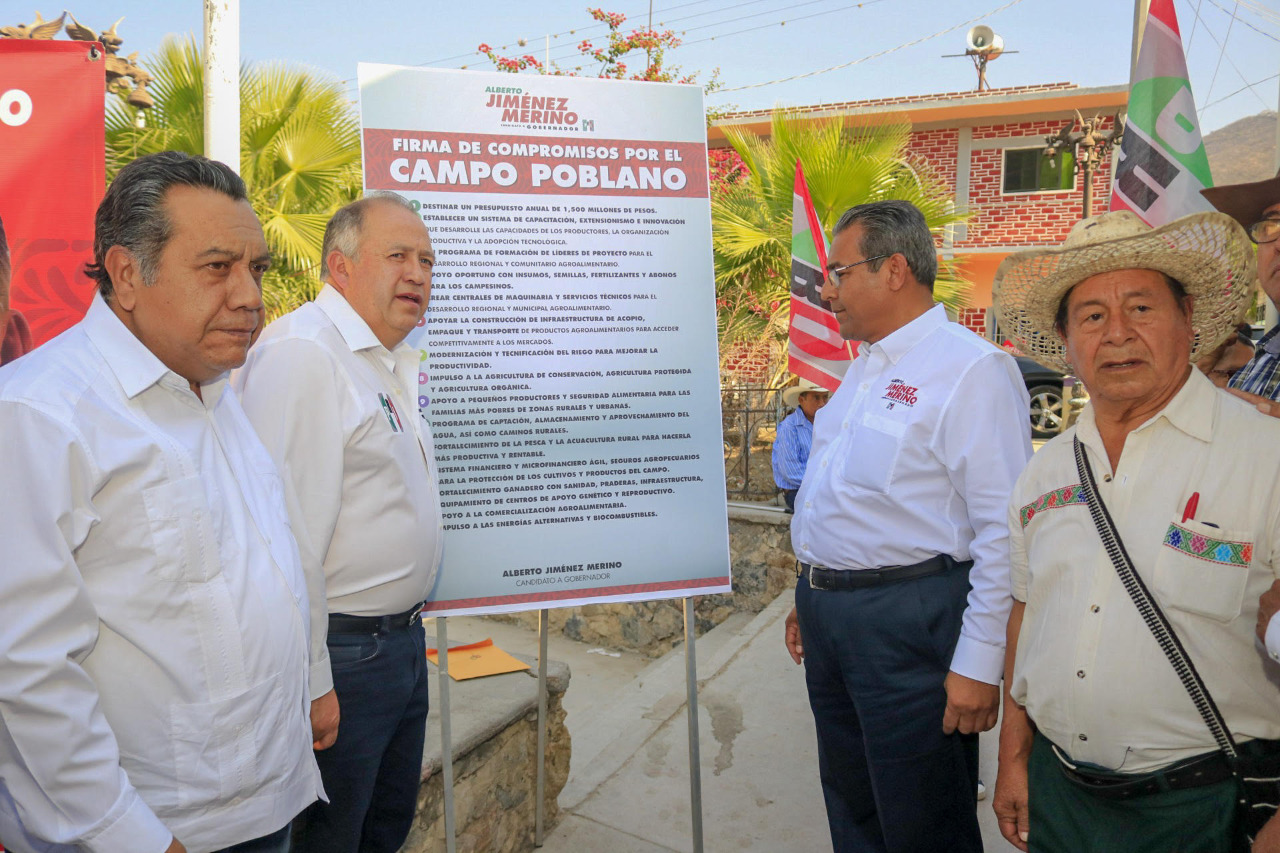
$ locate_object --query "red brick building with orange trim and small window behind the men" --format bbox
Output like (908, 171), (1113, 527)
(707, 83), (1129, 334)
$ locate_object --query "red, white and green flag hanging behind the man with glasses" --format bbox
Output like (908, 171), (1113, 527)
(787, 160), (852, 391)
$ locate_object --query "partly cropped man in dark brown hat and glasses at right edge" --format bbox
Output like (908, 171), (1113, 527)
(1201, 173), (1280, 416)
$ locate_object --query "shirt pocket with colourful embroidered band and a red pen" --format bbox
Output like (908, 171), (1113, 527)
(1155, 520), (1253, 622)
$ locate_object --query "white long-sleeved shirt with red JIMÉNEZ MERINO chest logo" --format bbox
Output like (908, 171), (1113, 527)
(791, 305), (1032, 684)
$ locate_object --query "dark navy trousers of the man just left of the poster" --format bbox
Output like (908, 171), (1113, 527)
(296, 624), (428, 853)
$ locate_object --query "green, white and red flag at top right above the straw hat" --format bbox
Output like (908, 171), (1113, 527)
(1111, 0), (1213, 228)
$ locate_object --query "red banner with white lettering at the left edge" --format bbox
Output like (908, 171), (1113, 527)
(0, 38), (106, 362)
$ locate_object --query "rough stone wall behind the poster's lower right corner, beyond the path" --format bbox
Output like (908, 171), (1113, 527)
(489, 503), (795, 657)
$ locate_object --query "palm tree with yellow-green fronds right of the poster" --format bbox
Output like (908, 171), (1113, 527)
(712, 110), (968, 384)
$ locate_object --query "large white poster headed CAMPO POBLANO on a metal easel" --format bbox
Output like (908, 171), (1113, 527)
(358, 64), (731, 616)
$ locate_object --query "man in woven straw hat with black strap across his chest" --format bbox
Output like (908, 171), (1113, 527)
(992, 211), (1280, 853)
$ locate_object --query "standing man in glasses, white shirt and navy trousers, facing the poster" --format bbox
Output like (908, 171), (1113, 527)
(786, 201), (1030, 853)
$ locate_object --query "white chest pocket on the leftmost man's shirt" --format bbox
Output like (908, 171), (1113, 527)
(142, 476), (218, 581)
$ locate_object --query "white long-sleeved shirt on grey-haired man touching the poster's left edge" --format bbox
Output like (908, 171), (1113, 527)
(234, 284), (443, 698)
